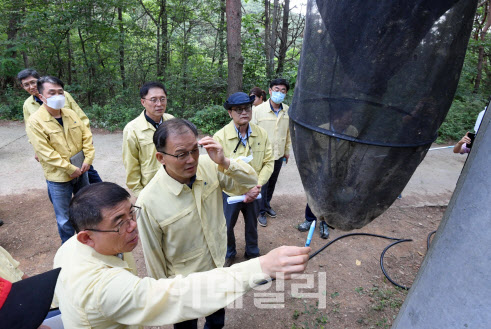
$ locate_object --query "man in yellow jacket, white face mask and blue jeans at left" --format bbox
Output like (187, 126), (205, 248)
(27, 76), (95, 243)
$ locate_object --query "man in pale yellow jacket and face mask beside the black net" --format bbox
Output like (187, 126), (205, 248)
(252, 79), (292, 226)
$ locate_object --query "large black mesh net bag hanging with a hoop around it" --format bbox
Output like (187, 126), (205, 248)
(289, 0), (477, 230)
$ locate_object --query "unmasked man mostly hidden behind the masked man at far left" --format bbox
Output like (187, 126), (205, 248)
(17, 69), (102, 184)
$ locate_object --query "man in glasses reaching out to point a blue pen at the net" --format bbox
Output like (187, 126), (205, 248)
(54, 182), (310, 329)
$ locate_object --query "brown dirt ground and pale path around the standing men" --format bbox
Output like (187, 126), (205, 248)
(0, 121), (466, 328)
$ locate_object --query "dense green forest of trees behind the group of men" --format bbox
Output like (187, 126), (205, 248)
(0, 0), (491, 142)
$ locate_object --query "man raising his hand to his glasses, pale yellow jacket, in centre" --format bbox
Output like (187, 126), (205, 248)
(136, 119), (257, 328)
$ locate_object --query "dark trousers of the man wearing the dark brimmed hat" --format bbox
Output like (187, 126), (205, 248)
(222, 193), (261, 258)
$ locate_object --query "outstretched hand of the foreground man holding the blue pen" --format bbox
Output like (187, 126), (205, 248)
(259, 246), (312, 279)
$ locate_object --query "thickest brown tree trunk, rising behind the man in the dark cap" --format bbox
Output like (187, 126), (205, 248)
(226, 0), (244, 95)
